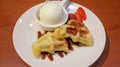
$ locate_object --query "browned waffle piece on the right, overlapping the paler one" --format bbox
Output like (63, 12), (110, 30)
(53, 20), (92, 46)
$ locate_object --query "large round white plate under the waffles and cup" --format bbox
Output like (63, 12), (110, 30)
(13, 2), (106, 67)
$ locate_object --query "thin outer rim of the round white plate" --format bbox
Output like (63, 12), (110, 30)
(12, 2), (106, 66)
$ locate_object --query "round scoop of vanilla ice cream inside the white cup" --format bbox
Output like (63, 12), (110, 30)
(39, 2), (64, 25)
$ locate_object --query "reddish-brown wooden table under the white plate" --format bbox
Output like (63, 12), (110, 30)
(0, 0), (120, 67)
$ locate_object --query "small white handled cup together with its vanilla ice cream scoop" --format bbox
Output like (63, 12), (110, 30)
(35, 0), (68, 31)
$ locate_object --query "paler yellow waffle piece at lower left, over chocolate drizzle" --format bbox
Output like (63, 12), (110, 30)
(32, 32), (68, 58)
